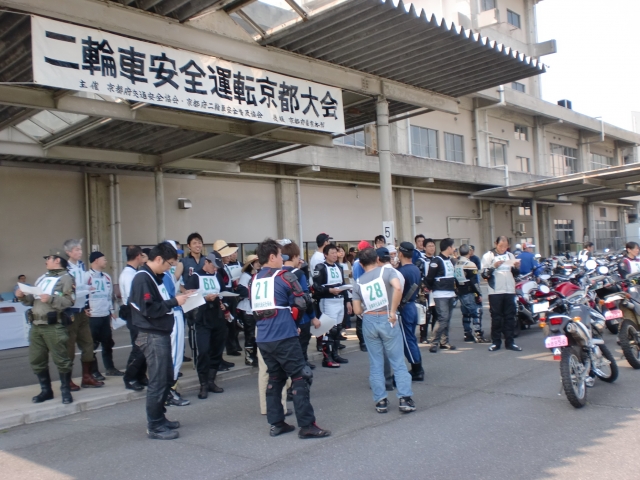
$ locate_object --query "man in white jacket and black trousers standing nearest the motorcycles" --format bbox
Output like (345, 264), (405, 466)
(481, 236), (522, 352)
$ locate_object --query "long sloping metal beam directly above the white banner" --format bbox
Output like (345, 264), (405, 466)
(0, 0), (458, 114)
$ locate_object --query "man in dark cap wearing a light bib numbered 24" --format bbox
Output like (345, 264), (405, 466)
(85, 252), (124, 377)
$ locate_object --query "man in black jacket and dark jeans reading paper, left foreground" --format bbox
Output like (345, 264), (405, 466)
(129, 243), (191, 440)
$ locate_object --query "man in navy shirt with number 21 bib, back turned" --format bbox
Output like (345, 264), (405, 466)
(249, 238), (331, 439)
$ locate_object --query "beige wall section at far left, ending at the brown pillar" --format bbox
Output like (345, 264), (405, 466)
(0, 167), (86, 292)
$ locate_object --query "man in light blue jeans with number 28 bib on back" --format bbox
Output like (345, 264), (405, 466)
(352, 248), (416, 413)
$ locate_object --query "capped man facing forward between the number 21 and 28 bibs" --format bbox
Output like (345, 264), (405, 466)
(313, 243), (352, 368)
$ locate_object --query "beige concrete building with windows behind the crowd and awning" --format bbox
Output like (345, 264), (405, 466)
(0, 0), (640, 291)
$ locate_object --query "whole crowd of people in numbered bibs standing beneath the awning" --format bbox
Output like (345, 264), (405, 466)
(15, 233), (521, 440)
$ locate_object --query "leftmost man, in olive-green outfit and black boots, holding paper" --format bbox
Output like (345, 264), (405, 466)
(15, 248), (76, 403)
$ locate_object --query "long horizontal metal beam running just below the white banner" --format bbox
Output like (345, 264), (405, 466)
(0, 85), (333, 147)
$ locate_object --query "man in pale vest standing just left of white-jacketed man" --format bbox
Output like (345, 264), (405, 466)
(454, 244), (487, 343)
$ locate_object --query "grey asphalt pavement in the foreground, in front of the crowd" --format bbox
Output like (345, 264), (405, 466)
(0, 320), (640, 479)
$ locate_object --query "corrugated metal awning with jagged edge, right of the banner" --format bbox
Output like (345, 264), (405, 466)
(260, 0), (545, 97)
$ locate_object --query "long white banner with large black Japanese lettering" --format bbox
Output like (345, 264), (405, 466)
(31, 16), (344, 133)
